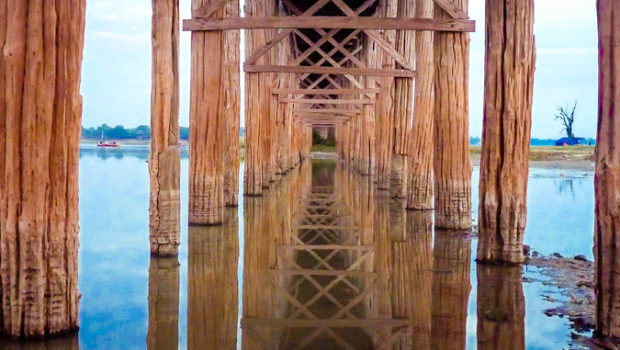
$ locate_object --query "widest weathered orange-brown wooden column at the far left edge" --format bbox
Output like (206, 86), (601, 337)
(0, 0), (86, 338)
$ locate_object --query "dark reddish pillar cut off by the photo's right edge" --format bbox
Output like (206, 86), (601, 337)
(594, 0), (620, 338)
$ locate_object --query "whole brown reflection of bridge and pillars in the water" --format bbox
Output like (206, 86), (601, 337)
(132, 162), (525, 350)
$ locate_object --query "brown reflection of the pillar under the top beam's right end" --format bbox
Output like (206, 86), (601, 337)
(431, 231), (471, 350)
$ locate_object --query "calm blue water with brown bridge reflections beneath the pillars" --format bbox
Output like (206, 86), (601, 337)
(0, 146), (594, 349)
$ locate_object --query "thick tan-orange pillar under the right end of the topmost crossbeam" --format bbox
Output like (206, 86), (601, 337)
(434, 0), (472, 229)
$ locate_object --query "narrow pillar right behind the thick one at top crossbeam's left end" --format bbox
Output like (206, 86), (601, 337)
(221, 1), (241, 207)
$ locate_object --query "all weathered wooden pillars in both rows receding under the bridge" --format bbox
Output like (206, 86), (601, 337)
(0, 0), (620, 338)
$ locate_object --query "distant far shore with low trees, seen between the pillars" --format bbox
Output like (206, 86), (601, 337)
(82, 138), (594, 171)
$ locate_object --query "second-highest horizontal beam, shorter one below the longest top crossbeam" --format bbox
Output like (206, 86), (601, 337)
(243, 65), (416, 78)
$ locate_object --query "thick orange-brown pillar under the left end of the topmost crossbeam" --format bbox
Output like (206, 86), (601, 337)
(189, 0), (227, 225)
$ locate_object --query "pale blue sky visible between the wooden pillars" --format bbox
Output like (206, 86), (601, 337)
(82, 0), (598, 138)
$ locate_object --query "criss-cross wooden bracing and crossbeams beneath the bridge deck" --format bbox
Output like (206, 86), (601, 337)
(183, 0), (475, 125)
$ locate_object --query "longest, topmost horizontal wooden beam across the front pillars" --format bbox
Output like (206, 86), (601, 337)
(183, 16), (476, 32)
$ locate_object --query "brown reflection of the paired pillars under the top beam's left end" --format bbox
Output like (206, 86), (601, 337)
(187, 209), (239, 350)
